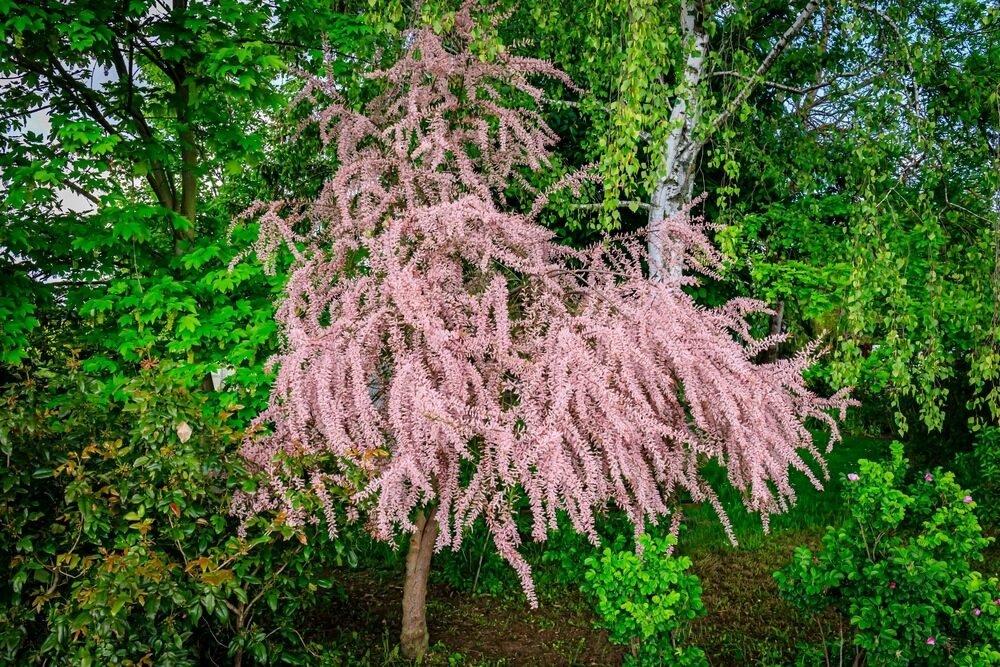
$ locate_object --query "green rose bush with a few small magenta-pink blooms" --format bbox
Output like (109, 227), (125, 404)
(775, 443), (1000, 667)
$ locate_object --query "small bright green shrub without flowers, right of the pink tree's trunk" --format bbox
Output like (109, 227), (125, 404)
(583, 535), (708, 665)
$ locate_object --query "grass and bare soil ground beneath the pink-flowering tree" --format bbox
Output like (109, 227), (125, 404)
(296, 437), (936, 667)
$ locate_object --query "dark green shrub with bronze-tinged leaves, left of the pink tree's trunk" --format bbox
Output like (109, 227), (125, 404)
(0, 356), (360, 665)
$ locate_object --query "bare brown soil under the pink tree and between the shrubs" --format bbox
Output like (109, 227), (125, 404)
(307, 532), (1000, 667)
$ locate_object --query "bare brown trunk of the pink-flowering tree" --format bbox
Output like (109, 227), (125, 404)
(399, 510), (438, 660)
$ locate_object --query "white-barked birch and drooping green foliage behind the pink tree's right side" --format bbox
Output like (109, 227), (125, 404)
(482, 0), (1000, 442)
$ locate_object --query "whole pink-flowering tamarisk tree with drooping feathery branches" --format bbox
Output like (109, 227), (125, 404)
(235, 5), (849, 657)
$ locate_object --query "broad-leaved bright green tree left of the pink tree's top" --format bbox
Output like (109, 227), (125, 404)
(0, 0), (372, 377)
